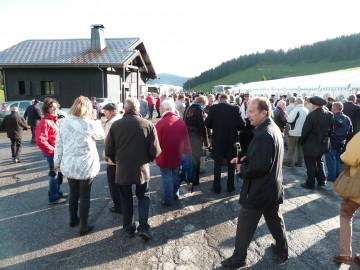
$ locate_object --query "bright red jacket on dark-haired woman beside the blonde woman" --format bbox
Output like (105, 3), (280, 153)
(35, 113), (59, 156)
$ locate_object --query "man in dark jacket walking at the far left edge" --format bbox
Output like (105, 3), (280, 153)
(0, 107), (27, 163)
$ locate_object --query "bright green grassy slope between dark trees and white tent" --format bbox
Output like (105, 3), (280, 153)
(192, 60), (360, 92)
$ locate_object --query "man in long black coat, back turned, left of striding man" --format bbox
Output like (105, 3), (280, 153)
(205, 94), (245, 194)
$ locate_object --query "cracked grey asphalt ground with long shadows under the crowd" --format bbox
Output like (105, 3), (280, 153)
(0, 121), (360, 270)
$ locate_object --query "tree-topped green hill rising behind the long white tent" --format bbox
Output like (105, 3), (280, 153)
(183, 33), (360, 92)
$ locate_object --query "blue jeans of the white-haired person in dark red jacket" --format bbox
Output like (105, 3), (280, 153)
(160, 168), (180, 204)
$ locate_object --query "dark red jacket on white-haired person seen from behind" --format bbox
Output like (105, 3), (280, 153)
(155, 112), (191, 169)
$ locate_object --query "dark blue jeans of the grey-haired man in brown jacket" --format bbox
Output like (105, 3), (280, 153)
(118, 182), (150, 233)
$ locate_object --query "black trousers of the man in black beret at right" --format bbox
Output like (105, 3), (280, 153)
(304, 155), (326, 187)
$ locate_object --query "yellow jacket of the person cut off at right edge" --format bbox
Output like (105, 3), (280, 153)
(340, 132), (360, 203)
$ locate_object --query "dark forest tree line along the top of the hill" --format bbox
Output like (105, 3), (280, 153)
(183, 33), (360, 89)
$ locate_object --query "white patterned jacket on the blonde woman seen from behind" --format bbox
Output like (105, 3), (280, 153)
(54, 116), (105, 180)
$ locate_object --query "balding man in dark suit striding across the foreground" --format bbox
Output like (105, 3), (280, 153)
(221, 97), (288, 269)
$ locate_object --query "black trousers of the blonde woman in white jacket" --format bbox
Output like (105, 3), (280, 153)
(68, 178), (92, 231)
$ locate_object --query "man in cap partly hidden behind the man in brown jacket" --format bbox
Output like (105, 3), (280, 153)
(103, 103), (123, 214)
